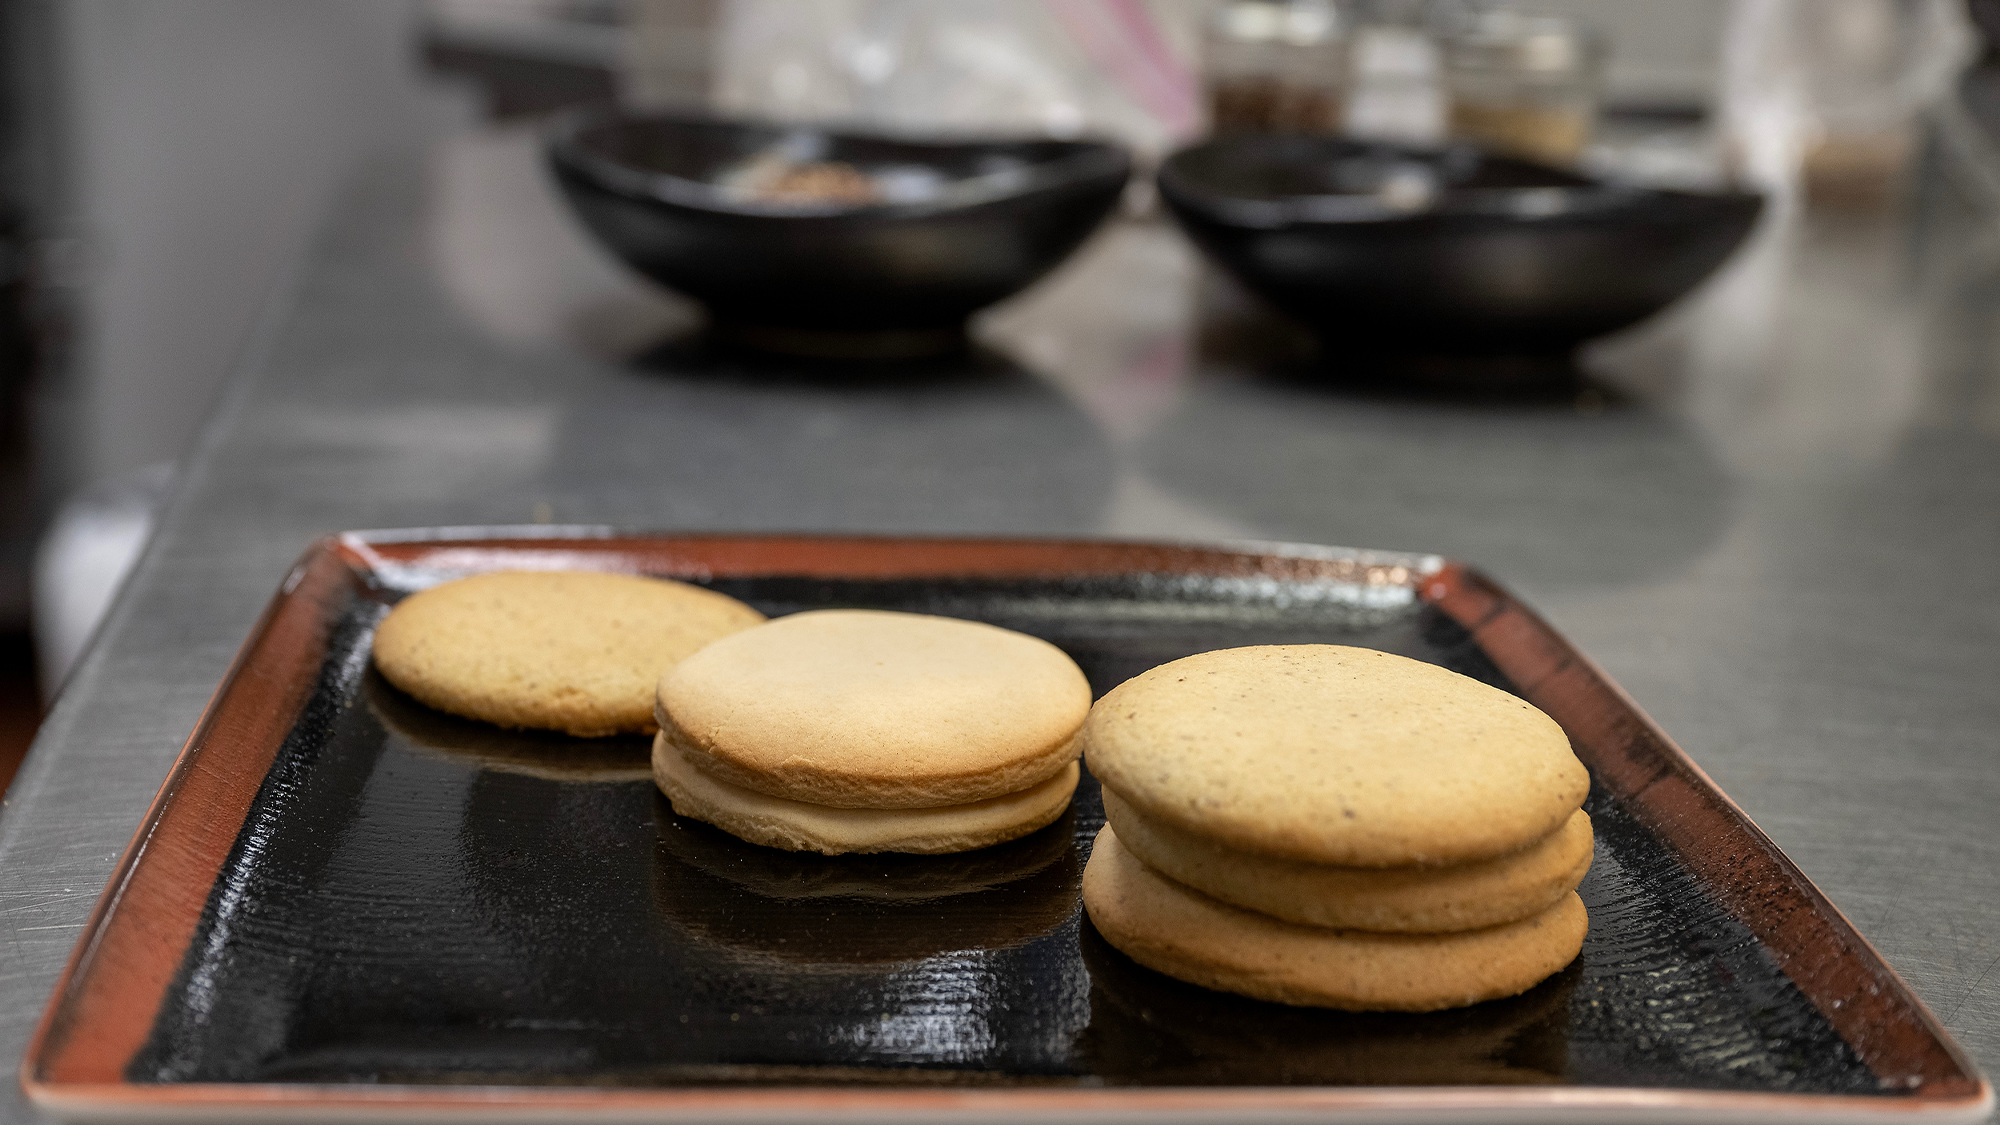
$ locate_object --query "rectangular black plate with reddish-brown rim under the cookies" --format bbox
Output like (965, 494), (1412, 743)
(22, 528), (1992, 1121)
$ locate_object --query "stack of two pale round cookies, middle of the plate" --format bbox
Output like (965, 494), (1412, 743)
(652, 611), (1090, 855)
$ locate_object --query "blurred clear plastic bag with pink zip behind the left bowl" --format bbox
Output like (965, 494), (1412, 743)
(714, 0), (1202, 154)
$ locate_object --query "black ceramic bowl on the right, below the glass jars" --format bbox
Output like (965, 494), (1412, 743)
(1160, 136), (1762, 356)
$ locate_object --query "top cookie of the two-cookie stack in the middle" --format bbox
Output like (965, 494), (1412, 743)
(658, 609), (1090, 809)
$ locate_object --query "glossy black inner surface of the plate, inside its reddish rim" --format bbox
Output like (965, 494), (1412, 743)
(124, 575), (1894, 1097)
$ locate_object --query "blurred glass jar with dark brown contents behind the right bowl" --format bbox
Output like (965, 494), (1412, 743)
(1204, 0), (1346, 134)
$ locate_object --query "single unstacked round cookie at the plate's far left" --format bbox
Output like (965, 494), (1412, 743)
(374, 571), (764, 737)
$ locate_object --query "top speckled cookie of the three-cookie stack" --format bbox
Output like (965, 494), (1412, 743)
(1080, 645), (1590, 867)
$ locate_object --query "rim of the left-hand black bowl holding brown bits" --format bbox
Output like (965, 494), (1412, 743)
(544, 106), (1132, 220)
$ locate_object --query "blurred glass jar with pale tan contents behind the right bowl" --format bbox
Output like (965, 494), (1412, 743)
(1444, 8), (1604, 164)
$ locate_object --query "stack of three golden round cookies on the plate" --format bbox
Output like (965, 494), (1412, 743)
(1082, 645), (1592, 1011)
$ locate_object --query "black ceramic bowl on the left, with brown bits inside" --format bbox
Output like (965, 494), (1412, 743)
(548, 110), (1130, 352)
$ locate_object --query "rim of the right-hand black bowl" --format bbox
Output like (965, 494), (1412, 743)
(1156, 134), (1764, 230)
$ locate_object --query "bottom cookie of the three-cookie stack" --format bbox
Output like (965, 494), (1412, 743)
(1084, 827), (1588, 1011)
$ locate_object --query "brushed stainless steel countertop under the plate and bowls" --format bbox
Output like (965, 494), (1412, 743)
(0, 124), (2000, 1121)
